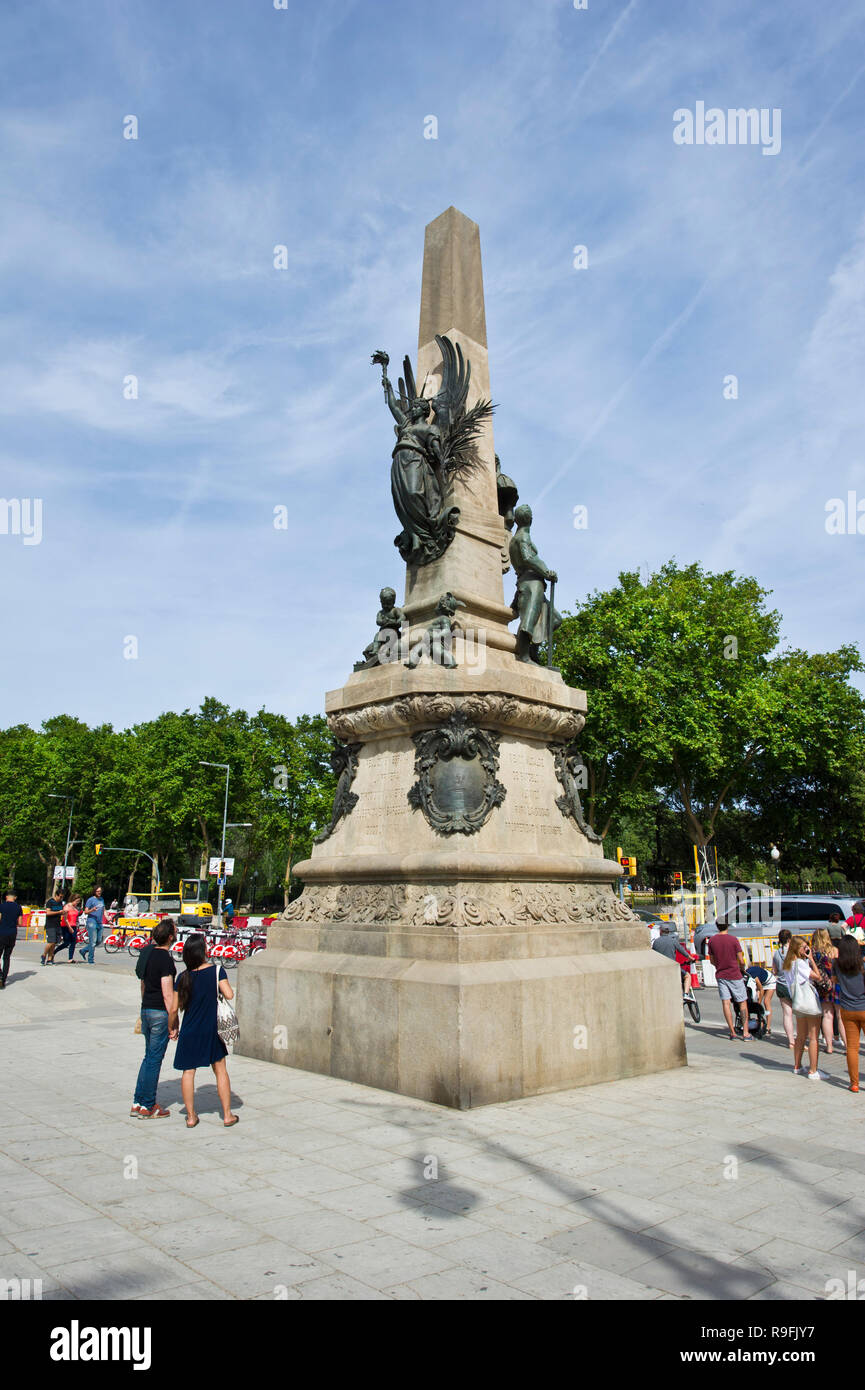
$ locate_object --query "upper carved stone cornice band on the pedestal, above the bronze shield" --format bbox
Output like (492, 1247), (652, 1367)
(327, 694), (585, 741)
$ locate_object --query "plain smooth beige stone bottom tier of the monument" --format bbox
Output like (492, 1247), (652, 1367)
(235, 923), (687, 1109)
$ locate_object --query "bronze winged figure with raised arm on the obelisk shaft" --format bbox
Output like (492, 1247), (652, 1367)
(373, 334), (494, 564)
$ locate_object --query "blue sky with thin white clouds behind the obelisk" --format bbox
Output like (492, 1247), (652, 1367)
(0, 0), (865, 727)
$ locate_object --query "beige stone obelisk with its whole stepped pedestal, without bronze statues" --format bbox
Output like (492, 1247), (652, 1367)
(238, 207), (686, 1109)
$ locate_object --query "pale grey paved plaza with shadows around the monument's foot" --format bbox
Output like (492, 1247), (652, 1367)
(0, 944), (865, 1300)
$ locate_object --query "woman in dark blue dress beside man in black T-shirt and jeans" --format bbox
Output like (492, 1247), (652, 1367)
(174, 935), (241, 1129)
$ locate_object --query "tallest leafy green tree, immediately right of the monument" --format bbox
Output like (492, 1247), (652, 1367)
(555, 562), (780, 845)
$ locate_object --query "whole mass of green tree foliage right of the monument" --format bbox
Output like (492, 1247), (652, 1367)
(555, 562), (865, 877)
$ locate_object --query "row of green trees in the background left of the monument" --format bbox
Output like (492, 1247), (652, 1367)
(0, 699), (335, 902)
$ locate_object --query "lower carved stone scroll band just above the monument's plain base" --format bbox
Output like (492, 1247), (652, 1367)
(282, 883), (640, 927)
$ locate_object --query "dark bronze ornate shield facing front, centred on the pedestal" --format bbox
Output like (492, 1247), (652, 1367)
(407, 709), (506, 835)
